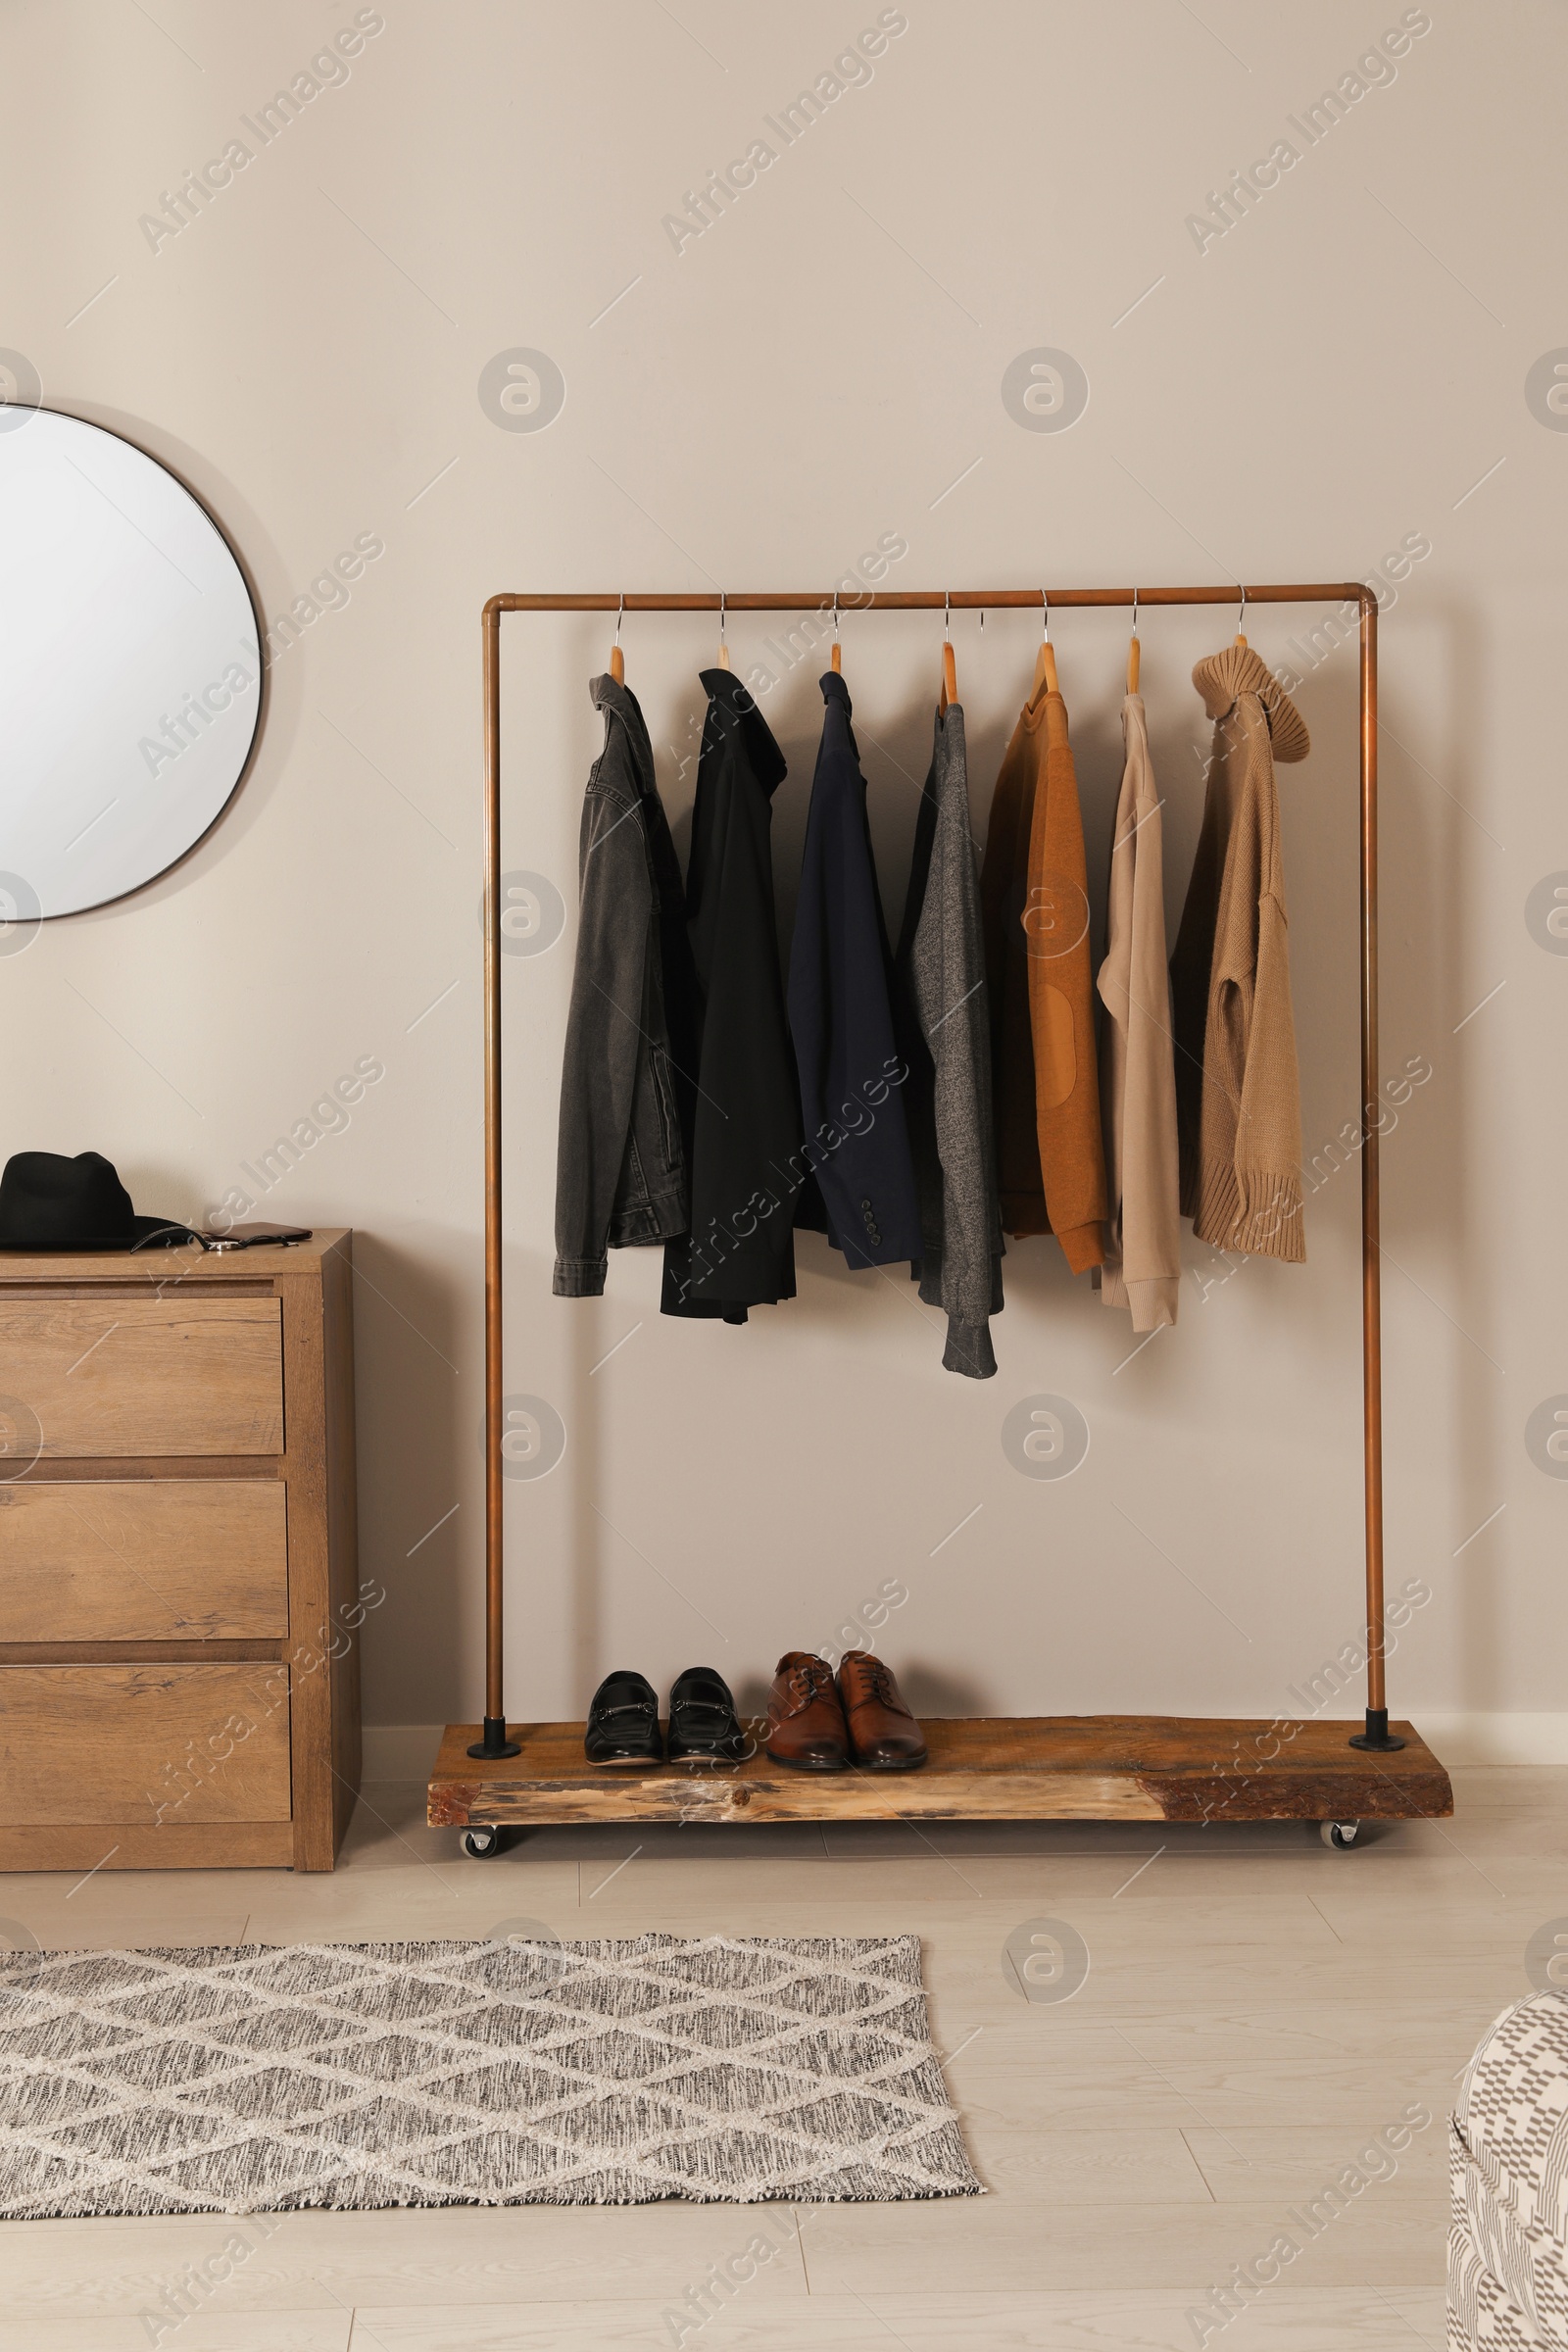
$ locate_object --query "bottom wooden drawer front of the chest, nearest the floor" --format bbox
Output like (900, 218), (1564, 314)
(0, 1665), (289, 1848)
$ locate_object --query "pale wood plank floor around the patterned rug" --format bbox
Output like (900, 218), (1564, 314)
(0, 1771), (1568, 2352)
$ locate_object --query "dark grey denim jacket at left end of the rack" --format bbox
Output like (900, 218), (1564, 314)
(553, 677), (698, 1298)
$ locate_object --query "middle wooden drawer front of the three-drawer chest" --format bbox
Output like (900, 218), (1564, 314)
(0, 1477), (289, 1642)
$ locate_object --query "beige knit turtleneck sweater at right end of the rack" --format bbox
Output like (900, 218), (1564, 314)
(1171, 645), (1312, 1263)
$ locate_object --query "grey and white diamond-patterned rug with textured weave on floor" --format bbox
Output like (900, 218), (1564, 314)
(0, 1936), (980, 2221)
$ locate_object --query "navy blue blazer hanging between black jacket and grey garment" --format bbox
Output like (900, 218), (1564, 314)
(790, 670), (924, 1265)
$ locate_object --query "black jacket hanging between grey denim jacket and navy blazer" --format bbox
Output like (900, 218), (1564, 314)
(662, 670), (804, 1322)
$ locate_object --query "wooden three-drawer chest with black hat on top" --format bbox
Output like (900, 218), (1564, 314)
(0, 1233), (362, 1872)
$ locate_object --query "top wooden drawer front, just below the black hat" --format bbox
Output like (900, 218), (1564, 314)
(0, 1296), (282, 1460)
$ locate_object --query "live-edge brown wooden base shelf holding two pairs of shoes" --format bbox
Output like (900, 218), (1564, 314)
(430, 1715), (1452, 1830)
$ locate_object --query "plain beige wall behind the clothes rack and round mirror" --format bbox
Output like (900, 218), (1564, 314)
(0, 0), (1568, 1724)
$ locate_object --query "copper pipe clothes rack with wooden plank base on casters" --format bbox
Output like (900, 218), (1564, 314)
(430, 581), (1452, 1853)
